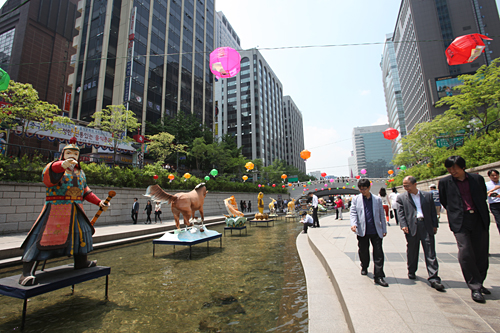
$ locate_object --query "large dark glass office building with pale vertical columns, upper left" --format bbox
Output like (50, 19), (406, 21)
(69, 0), (215, 132)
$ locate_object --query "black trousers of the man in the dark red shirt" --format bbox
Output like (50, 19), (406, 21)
(455, 213), (490, 290)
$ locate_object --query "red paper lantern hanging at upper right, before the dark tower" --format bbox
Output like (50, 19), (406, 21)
(445, 34), (492, 66)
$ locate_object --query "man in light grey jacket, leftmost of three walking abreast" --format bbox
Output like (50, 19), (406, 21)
(350, 178), (389, 287)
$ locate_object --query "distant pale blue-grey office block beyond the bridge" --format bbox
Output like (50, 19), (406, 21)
(349, 125), (393, 178)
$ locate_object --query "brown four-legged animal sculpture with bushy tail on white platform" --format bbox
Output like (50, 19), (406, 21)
(144, 183), (208, 229)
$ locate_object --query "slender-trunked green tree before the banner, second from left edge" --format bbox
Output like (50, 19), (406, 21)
(88, 105), (141, 164)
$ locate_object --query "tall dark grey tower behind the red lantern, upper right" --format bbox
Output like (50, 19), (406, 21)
(393, 0), (500, 132)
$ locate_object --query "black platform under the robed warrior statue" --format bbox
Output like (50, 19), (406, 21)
(0, 265), (111, 330)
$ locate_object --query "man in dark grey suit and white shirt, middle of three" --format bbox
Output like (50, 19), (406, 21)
(396, 176), (444, 291)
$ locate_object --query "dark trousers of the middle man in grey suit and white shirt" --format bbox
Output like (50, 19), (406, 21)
(405, 221), (441, 282)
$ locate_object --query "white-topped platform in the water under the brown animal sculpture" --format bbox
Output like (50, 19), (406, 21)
(153, 226), (222, 259)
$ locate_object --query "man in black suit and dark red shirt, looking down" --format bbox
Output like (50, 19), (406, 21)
(439, 156), (491, 303)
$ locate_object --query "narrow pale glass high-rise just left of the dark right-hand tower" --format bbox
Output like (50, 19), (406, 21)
(380, 33), (406, 154)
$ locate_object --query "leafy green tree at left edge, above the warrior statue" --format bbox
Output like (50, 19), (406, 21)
(0, 81), (73, 145)
